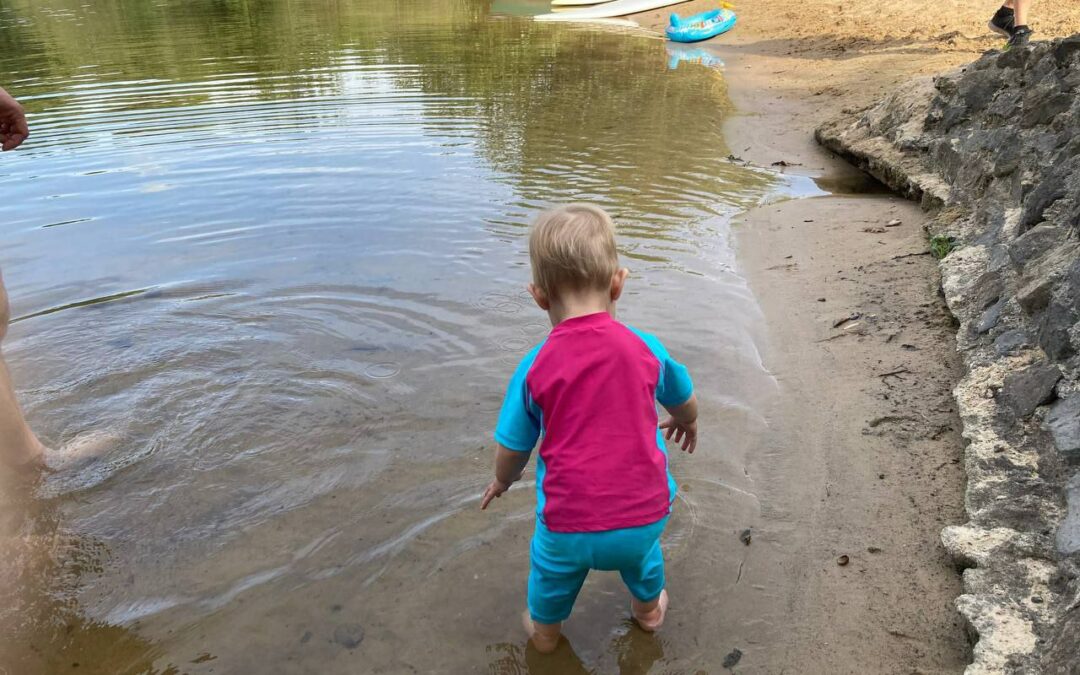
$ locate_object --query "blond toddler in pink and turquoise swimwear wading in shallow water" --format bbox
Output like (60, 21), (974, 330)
(481, 204), (698, 652)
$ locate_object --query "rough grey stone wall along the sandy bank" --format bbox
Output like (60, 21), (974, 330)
(816, 36), (1080, 675)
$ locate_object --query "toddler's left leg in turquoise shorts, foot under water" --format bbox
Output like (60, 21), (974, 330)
(525, 523), (589, 653)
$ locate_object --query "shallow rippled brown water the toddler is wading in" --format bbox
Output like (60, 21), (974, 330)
(0, 0), (805, 673)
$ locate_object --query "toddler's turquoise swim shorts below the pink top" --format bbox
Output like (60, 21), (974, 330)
(528, 516), (671, 623)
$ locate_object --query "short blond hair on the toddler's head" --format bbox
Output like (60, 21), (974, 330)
(529, 199), (619, 298)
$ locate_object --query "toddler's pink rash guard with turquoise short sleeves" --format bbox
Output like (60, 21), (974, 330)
(495, 312), (693, 532)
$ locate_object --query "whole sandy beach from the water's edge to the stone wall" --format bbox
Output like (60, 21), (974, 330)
(622, 0), (1080, 673)
